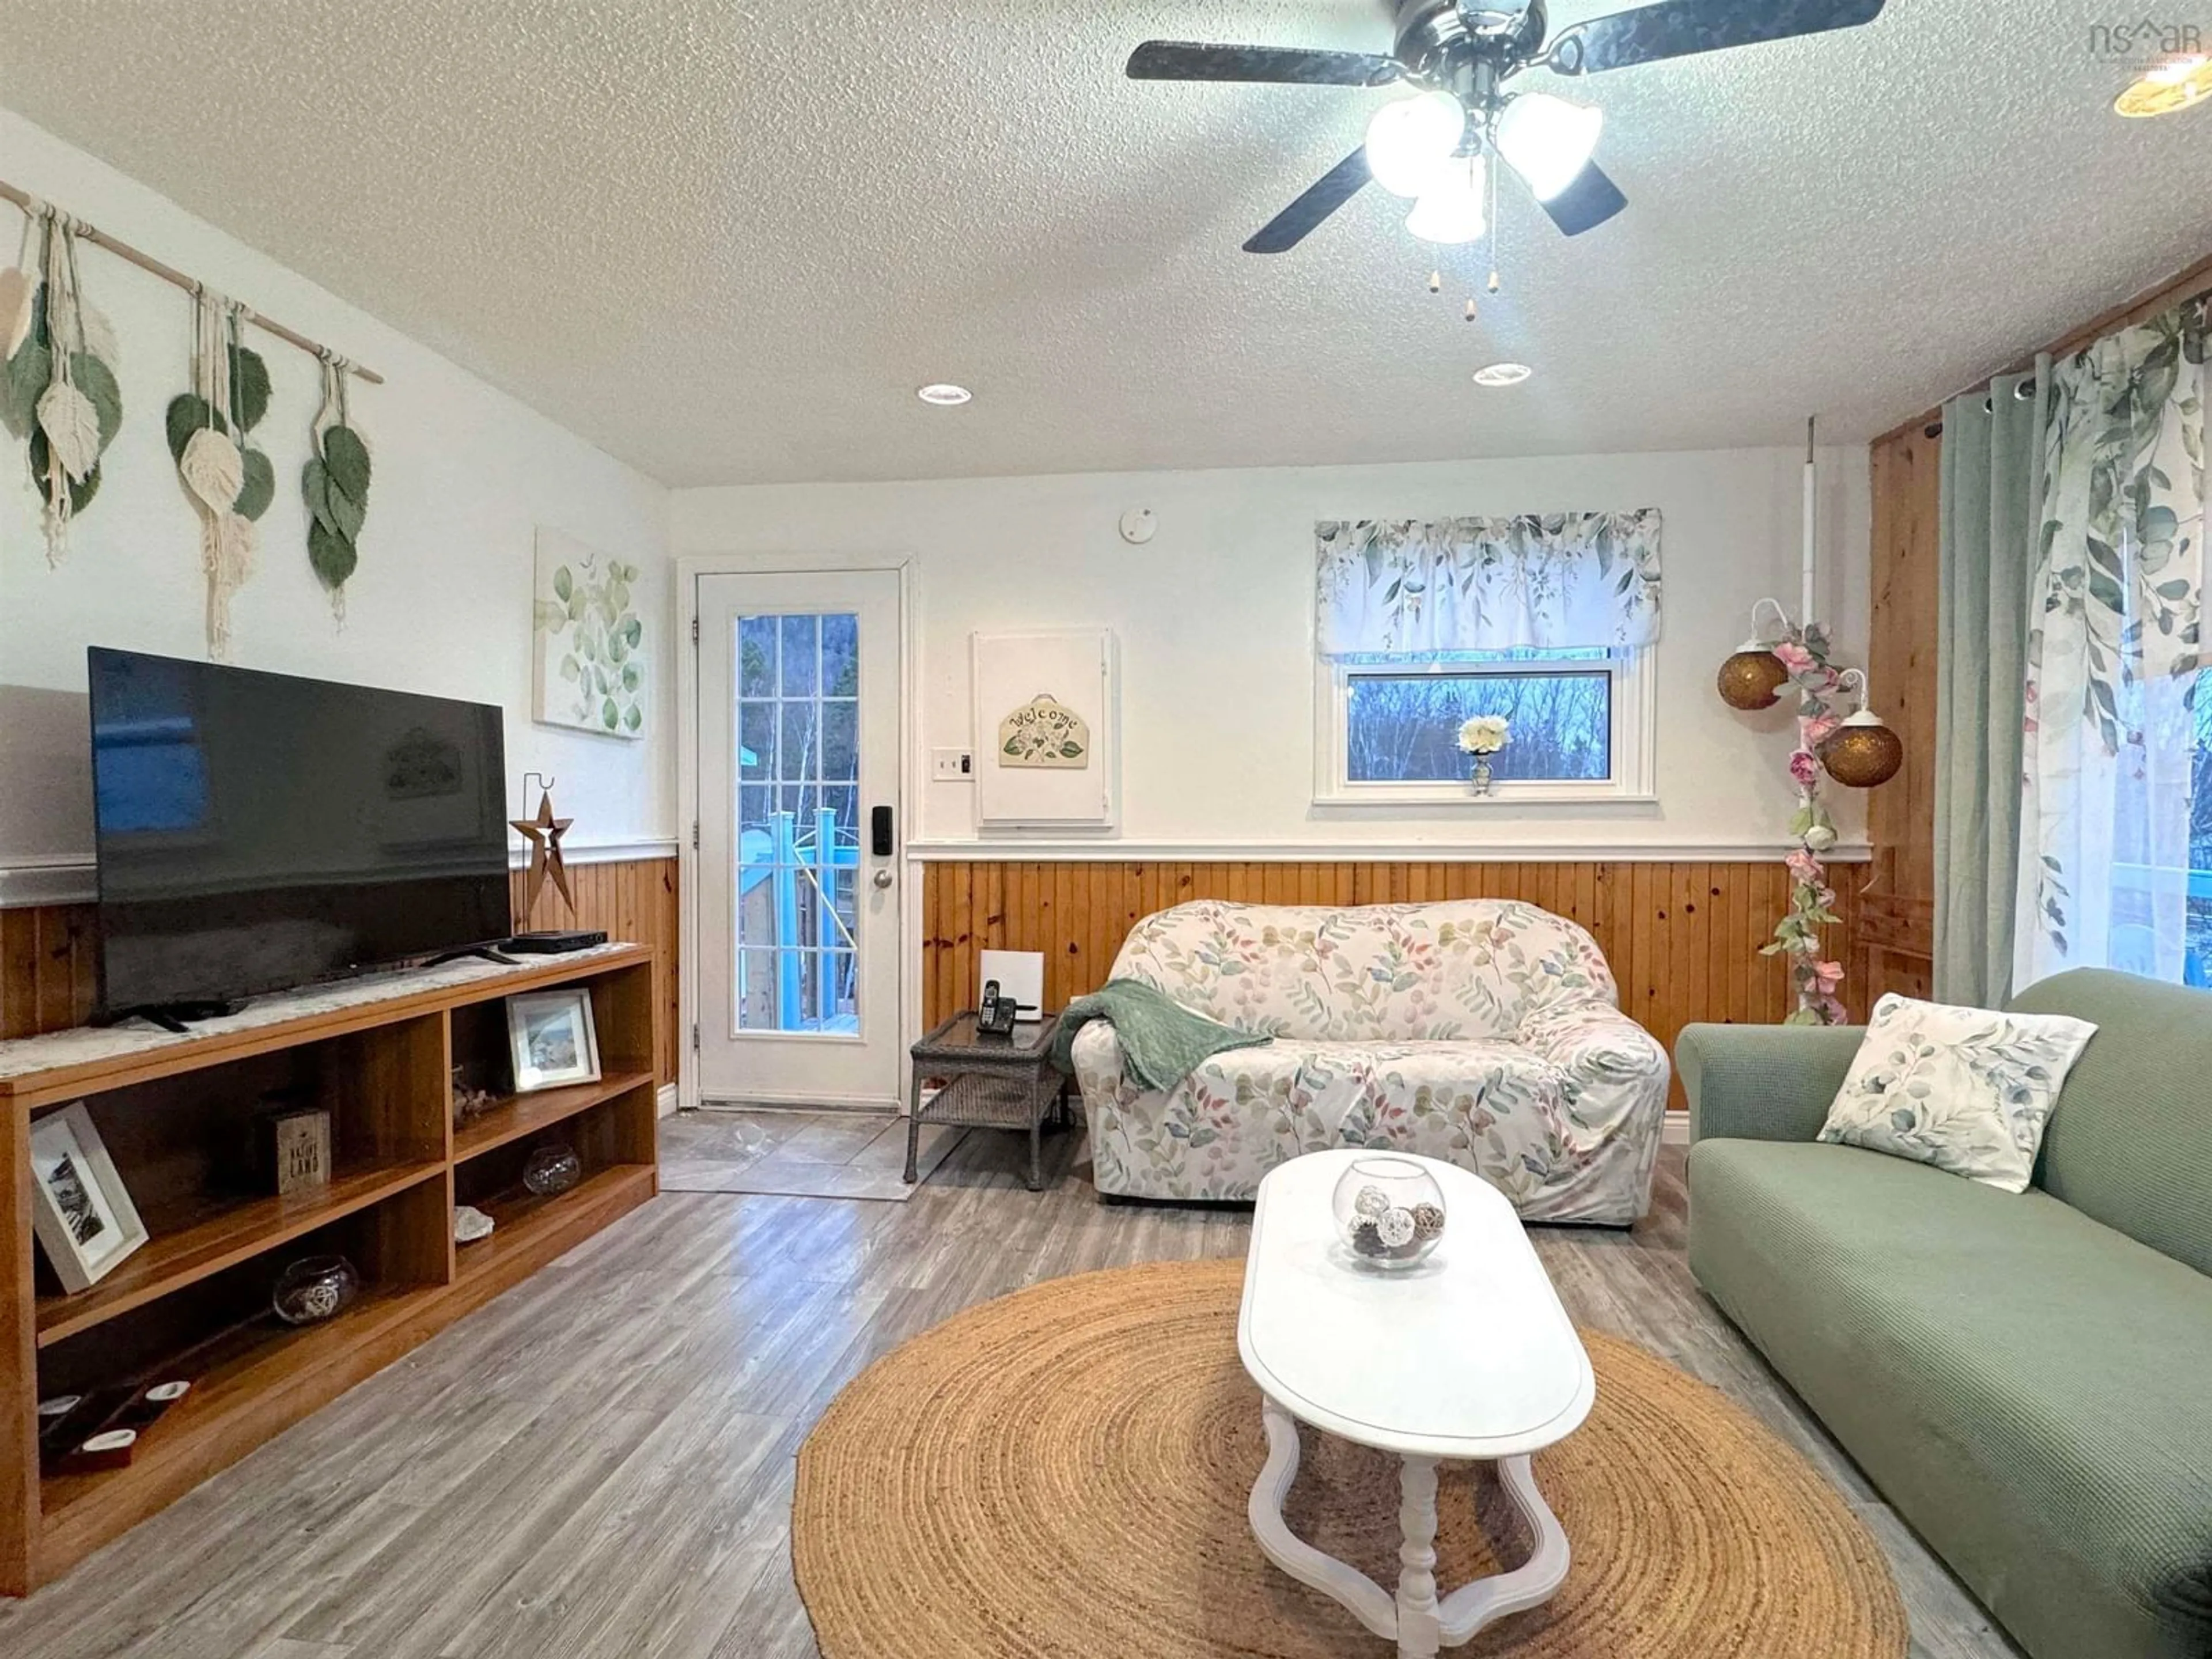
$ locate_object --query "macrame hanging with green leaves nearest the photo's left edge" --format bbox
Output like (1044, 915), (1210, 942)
(0, 203), (124, 564)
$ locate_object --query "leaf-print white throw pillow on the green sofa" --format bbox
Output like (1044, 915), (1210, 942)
(1820, 993), (2097, 1192)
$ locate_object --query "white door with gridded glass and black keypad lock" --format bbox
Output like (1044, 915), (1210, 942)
(697, 571), (905, 1106)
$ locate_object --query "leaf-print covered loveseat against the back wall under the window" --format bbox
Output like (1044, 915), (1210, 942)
(1073, 898), (1668, 1225)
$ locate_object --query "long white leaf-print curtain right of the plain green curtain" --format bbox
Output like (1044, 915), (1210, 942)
(2015, 298), (2207, 987)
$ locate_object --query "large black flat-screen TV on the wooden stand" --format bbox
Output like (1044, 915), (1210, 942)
(86, 648), (513, 1017)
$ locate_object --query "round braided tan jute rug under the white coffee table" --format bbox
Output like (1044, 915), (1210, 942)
(792, 1261), (1907, 1659)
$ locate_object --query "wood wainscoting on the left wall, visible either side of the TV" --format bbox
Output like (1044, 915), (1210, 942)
(0, 858), (677, 1084)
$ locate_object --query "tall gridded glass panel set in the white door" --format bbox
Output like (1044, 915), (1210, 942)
(732, 613), (861, 1033)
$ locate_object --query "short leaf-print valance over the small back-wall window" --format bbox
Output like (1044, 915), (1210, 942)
(1314, 506), (1659, 657)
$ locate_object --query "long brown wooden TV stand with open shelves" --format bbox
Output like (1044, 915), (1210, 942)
(0, 945), (659, 1595)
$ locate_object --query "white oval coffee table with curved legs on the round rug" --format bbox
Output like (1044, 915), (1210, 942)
(1237, 1150), (1597, 1659)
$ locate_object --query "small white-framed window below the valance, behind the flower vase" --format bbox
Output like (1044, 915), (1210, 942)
(1316, 650), (1650, 805)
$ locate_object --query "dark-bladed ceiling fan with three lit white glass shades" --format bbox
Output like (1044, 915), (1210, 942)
(1128, 0), (1885, 255)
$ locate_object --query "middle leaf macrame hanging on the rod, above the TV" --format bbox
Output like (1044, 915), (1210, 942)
(168, 287), (276, 657)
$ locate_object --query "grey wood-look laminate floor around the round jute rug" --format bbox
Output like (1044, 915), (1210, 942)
(0, 1126), (2013, 1659)
